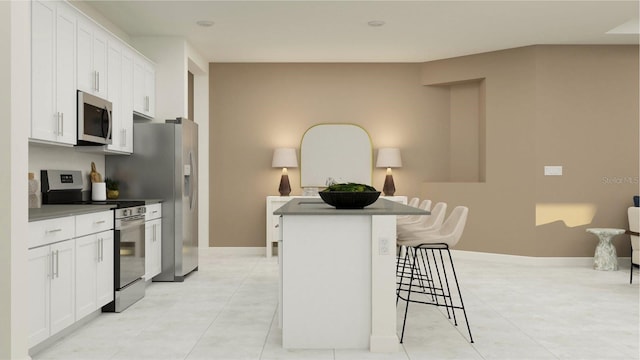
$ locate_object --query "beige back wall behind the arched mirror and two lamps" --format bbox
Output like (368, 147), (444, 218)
(209, 63), (442, 246)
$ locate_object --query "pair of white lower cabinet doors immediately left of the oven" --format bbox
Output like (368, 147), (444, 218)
(75, 230), (113, 320)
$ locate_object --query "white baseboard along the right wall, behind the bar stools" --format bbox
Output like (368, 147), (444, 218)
(451, 250), (629, 266)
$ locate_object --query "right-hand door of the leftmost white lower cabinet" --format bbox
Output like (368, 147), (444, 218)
(50, 240), (76, 335)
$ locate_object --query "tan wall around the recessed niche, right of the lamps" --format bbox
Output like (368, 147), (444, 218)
(421, 46), (638, 256)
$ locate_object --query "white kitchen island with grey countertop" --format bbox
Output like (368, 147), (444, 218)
(274, 198), (429, 352)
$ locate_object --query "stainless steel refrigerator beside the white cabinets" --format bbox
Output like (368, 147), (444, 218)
(105, 118), (198, 281)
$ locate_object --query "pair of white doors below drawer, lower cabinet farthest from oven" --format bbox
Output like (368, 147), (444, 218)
(28, 239), (76, 347)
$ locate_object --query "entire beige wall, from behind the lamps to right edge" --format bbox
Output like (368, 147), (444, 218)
(209, 46), (639, 256)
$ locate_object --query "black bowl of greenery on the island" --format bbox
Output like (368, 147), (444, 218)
(318, 183), (380, 209)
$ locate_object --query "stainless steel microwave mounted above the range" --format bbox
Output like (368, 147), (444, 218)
(78, 90), (113, 145)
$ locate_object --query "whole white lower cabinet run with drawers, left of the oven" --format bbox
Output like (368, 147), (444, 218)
(27, 210), (114, 348)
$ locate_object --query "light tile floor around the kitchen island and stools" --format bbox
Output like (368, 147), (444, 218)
(33, 249), (640, 360)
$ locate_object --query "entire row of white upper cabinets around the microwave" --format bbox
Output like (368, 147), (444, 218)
(29, 0), (155, 149)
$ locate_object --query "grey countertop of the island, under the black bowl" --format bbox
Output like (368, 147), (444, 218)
(273, 198), (430, 215)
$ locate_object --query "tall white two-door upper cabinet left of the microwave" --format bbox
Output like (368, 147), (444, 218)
(30, 1), (77, 145)
